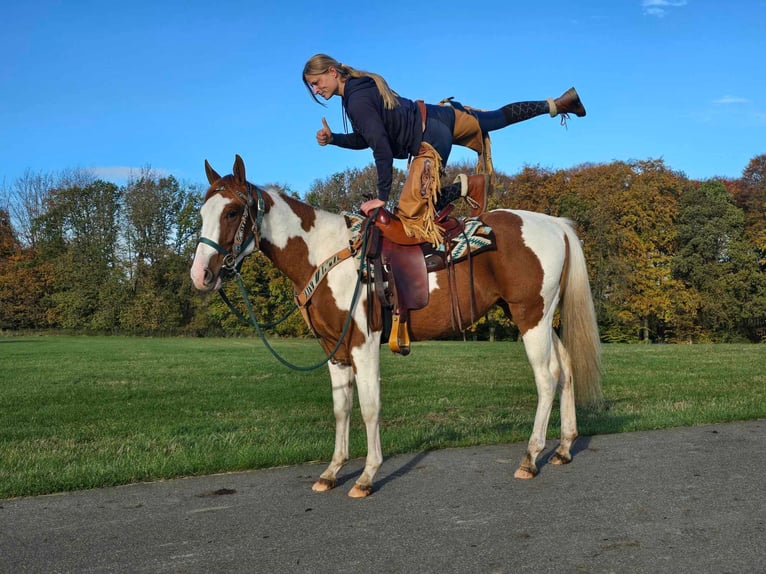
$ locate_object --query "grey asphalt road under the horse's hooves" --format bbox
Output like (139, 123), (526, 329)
(0, 420), (766, 574)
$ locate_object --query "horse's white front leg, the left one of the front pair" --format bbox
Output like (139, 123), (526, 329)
(312, 363), (354, 492)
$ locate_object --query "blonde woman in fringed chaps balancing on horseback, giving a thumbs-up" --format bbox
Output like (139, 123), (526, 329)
(303, 54), (585, 244)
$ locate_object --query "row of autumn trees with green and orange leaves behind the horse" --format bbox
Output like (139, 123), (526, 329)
(0, 155), (766, 342)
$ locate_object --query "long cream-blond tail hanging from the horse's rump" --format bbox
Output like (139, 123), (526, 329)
(560, 220), (603, 405)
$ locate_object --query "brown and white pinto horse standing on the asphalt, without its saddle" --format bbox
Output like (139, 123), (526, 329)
(191, 155), (601, 498)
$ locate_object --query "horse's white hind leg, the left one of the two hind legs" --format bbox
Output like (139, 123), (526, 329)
(513, 319), (560, 479)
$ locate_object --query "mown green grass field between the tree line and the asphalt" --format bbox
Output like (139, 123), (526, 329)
(0, 336), (766, 498)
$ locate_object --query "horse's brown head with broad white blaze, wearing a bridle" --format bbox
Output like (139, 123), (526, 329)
(191, 155), (263, 291)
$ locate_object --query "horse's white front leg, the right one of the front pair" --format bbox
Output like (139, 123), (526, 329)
(348, 332), (383, 498)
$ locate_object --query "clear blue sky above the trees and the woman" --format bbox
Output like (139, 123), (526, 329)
(0, 0), (766, 194)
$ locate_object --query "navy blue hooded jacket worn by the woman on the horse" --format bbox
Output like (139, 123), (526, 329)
(332, 76), (423, 201)
